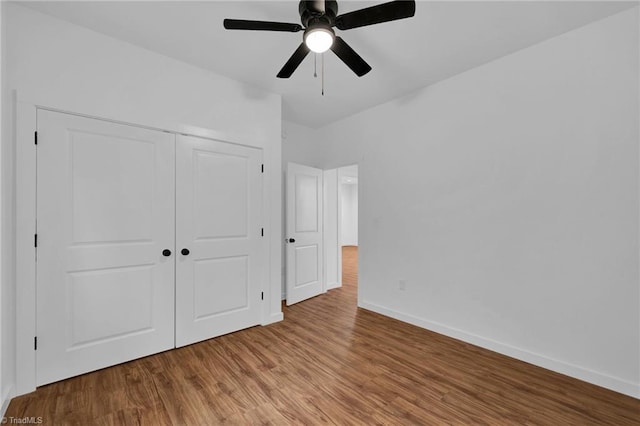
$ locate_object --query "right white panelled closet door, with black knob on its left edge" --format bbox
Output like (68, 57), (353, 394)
(176, 136), (264, 346)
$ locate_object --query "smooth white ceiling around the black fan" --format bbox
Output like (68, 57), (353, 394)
(18, 0), (638, 127)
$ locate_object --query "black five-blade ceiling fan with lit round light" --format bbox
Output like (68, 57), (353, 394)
(224, 0), (416, 78)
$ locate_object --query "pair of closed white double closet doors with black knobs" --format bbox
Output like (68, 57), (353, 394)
(36, 110), (262, 385)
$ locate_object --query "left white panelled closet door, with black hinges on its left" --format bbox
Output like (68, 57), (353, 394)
(36, 110), (175, 385)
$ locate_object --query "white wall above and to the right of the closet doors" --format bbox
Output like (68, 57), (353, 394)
(2, 4), (282, 392)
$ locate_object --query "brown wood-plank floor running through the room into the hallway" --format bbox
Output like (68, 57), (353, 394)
(6, 247), (640, 425)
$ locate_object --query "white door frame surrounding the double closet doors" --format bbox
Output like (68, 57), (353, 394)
(14, 95), (284, 398)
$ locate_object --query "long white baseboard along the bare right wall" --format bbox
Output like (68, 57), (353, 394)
(359, 301), (640, 399)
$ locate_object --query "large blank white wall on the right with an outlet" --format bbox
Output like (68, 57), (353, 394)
(319, 8), (640, 397)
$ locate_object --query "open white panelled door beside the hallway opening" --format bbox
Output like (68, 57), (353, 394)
(286, 163), (324, 305)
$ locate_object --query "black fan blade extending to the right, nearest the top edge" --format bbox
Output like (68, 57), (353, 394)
(336, 0), (416, 30)
